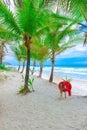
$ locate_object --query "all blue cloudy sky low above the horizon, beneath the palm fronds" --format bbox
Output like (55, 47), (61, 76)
(4, 44), (87, 67)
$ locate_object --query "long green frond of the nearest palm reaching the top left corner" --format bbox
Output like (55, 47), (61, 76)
(0, 1), (21, 34)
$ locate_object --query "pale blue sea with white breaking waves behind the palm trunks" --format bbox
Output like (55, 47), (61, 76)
(35, 67), (87, 81)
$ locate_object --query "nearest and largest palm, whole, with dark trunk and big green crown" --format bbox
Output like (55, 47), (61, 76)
(0, 0), (58, 92)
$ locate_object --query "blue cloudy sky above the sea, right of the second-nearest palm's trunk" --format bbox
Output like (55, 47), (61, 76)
(56, 45), (87, 67)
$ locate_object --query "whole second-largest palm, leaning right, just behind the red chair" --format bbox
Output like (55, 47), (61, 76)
(45, 22), (81, 82)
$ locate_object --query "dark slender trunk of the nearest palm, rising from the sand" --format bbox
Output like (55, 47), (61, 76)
(24, 48), (30, 91)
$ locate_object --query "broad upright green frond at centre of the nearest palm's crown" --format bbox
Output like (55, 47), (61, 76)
(16, 0), (36, 35)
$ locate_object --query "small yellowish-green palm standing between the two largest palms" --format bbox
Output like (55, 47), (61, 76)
(31, 37), (48, 78)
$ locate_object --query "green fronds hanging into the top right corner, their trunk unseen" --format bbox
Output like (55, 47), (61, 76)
(59, 0), (87, 21)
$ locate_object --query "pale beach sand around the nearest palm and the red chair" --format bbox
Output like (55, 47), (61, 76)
(0, 72), (87, 130)
